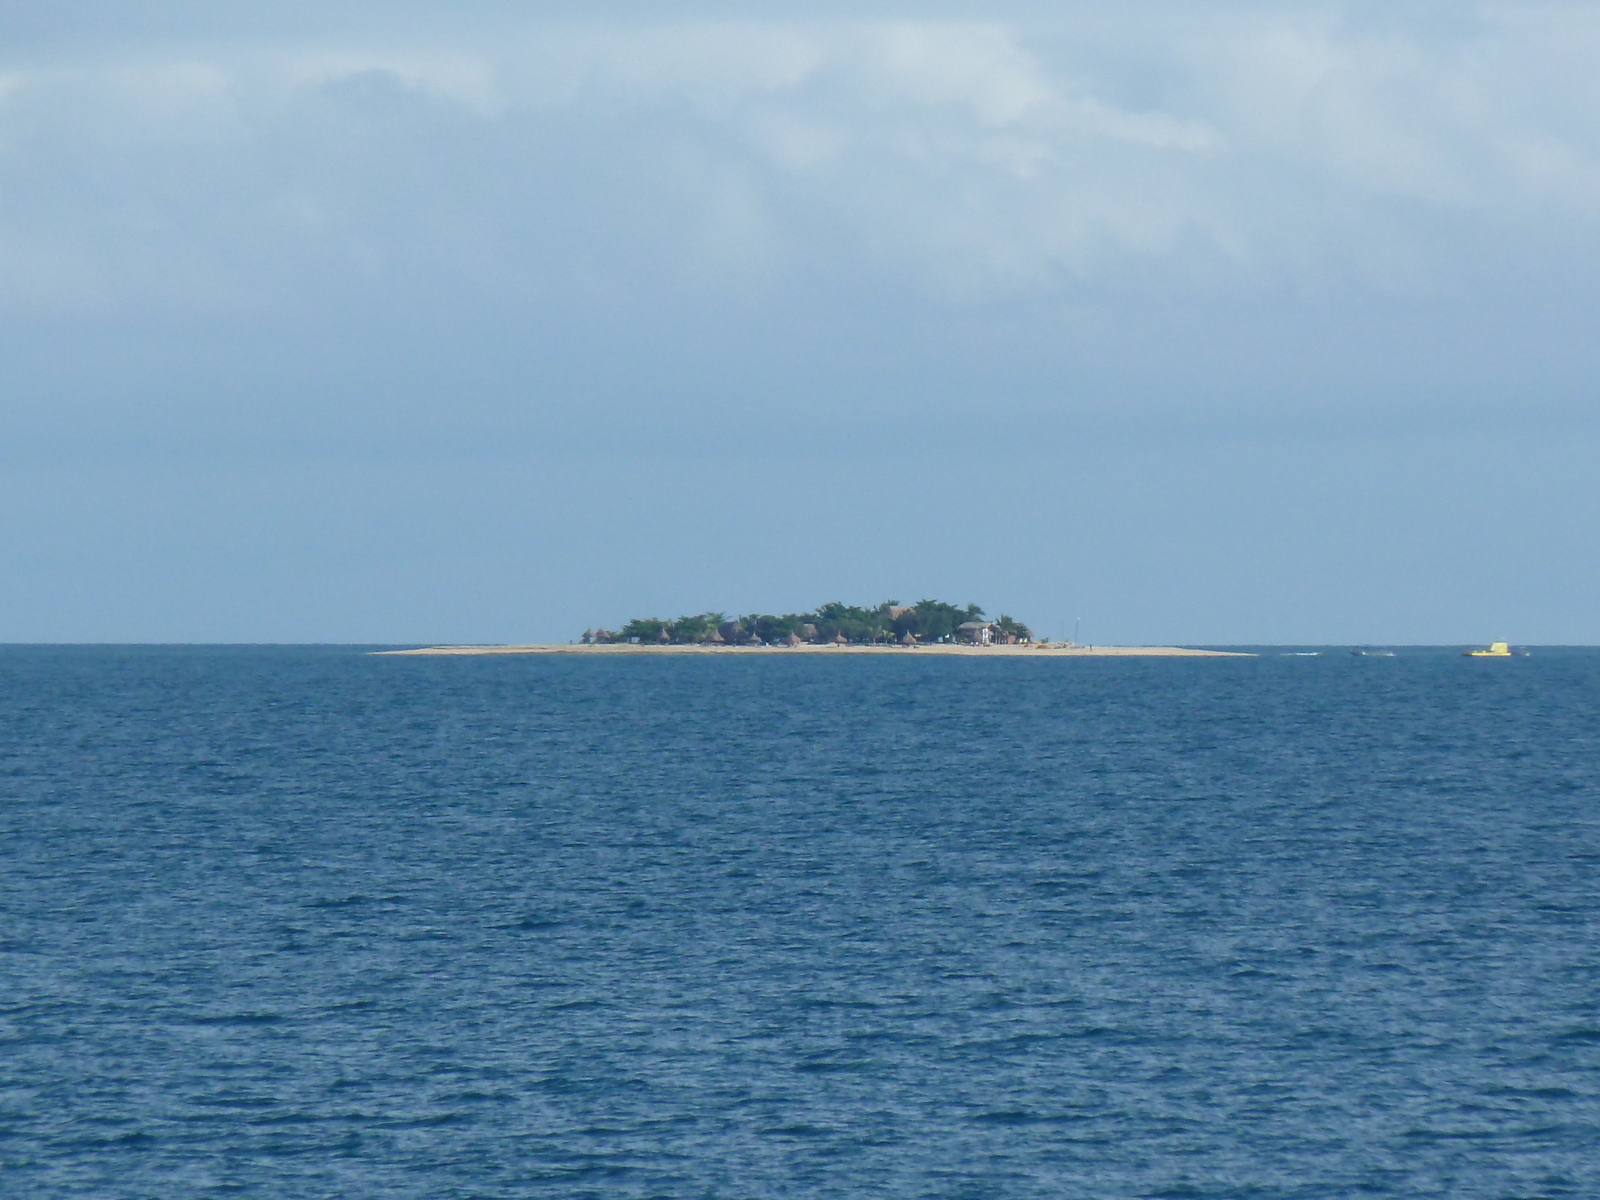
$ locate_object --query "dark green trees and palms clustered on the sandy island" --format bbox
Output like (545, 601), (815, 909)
(582, 600), (1034, 645)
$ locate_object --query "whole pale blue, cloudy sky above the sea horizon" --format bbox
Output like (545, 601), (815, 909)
(0, 0), (1600, 645)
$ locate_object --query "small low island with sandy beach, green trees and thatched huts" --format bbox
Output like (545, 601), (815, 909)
(374, 600), (1251, 658)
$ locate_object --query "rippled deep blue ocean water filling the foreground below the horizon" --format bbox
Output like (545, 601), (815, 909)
(0, 648), (1600, 1200)
